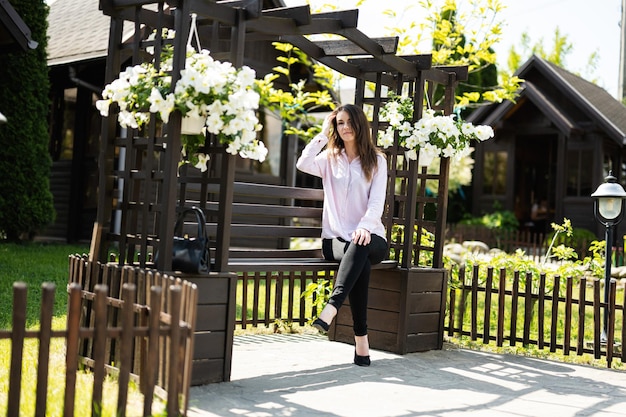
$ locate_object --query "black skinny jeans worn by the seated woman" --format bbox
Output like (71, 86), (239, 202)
(322, 234), (389, 336)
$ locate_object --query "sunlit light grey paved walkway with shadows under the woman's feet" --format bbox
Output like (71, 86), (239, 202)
(189, 335), (626, 417)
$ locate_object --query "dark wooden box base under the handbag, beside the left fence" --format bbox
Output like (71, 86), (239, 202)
(184, 272), (237, 385)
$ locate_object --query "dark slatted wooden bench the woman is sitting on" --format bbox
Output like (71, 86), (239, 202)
(177, 182), (398, 272)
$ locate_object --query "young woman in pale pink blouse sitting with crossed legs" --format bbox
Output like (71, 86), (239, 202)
(296, 104), (388, 366)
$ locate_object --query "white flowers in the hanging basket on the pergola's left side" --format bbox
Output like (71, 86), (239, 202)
(96, 31), (267, 170)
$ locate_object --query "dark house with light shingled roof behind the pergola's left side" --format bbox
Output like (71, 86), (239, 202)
(41, 0), (286, 242)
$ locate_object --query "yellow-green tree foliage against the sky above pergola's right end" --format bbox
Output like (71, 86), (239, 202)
(372, 0), (522, 108)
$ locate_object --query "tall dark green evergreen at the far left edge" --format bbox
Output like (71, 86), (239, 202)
(0, 0), (54, 240)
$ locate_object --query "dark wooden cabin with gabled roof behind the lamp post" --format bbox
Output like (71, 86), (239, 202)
(468, 56), (626, 239)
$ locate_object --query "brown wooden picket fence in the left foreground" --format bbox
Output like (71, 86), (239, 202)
(0, 255), (197, 417)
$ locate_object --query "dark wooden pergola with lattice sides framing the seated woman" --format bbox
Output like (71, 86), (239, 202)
(90, 0), (467, 272)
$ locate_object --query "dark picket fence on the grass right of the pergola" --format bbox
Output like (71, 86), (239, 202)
(445, 266), (626, 367)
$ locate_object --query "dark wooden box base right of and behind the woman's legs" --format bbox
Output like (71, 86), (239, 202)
(328, 268), (447, 355)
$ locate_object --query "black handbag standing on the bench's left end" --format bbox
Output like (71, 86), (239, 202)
(172, 207), (211, 274)
